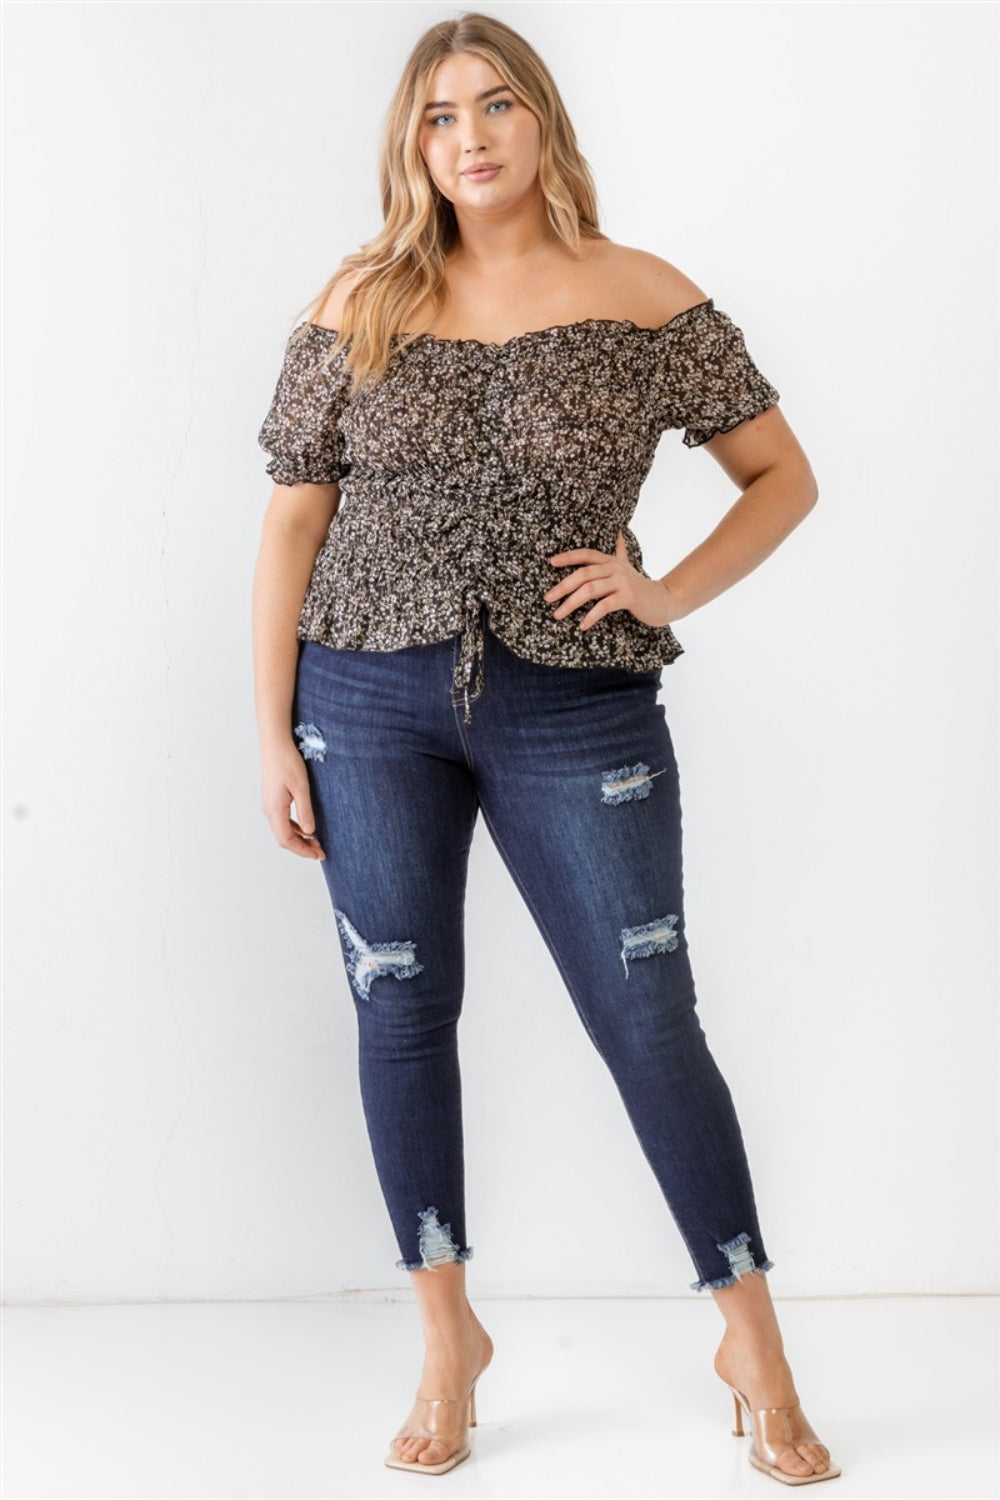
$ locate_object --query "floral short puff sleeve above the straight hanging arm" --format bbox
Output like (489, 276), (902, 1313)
(258, 323), (351, 485)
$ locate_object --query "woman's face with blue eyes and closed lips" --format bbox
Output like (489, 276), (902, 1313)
(420, 53), (541, 213)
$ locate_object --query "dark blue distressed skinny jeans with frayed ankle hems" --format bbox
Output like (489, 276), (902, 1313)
(292, 603), (774, 1292)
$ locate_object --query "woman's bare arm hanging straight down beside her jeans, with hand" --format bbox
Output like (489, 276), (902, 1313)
(252, 485), (340, 860)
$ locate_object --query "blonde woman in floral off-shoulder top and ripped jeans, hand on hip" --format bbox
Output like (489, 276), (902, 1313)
(253, 14), (840, 1484)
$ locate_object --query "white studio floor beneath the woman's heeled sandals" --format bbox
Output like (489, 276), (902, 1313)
(3, 1296), (1000, 1500)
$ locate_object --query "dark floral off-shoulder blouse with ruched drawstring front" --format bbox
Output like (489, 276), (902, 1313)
(258, 297), (780, 722)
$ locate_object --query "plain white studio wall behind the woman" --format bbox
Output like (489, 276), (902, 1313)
(3, 0), (999, 1302)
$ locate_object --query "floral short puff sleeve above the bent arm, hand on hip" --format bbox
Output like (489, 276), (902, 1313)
(657, 297), (781, 449)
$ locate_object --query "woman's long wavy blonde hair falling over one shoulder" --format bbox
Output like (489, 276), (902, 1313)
(284, 11), (607, 390)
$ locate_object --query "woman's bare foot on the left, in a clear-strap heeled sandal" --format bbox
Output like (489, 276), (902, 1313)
(390, 1310), (493, 1464)
